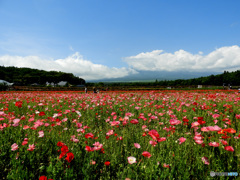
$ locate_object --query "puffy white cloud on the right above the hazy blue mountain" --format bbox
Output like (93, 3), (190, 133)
(124, 46), (240, 72)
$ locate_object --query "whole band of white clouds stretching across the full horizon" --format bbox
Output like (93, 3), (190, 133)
(0, 46), (240, 81)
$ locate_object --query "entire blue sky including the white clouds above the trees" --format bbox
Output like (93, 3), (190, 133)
(0, 0), (240, 81)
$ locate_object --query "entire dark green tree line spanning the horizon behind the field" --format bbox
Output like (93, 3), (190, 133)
(0, 66), (240, 87)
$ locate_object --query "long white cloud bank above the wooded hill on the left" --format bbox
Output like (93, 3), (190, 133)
(0, 53), (137, 81)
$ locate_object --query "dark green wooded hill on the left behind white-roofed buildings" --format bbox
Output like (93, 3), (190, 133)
(0, 66), (85, 85)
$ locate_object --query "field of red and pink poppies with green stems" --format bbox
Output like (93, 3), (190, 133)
(0, 90), (240, 180)
